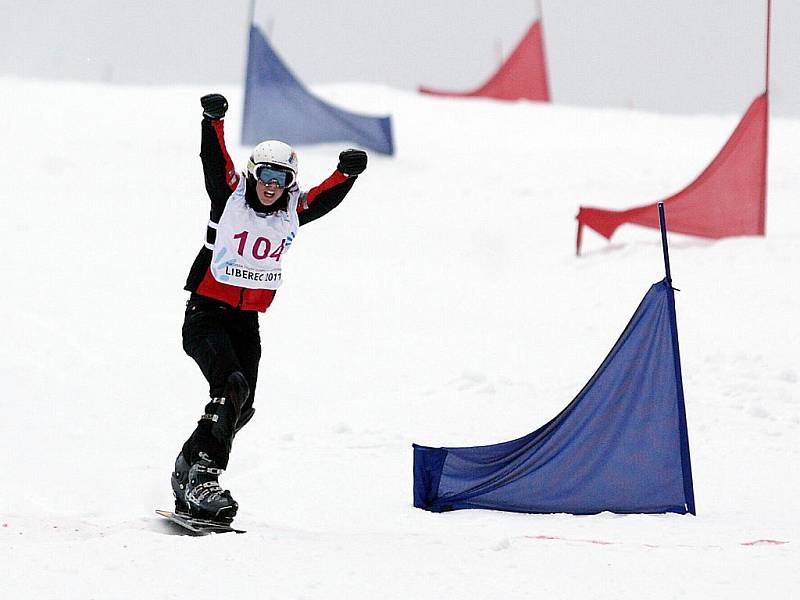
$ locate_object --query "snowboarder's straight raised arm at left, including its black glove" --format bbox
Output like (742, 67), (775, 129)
(200, 94), (239, 221)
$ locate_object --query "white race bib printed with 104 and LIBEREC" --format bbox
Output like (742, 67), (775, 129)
(211, 177), (300, 290)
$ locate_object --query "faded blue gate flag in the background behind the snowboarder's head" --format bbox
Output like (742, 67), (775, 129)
(242, 25), (394, 154)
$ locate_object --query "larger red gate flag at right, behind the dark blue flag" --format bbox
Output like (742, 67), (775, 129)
(576, 92), (768, 254)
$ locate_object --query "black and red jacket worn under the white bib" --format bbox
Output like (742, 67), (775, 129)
(184, 118), (356, 312)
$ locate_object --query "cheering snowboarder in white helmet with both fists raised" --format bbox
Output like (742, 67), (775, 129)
(171, 94), (367, 523)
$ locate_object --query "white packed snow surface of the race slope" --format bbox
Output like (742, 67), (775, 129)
(0, 79), (800, 600)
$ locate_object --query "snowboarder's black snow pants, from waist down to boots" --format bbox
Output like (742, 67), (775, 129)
(182, 294), (261, 469)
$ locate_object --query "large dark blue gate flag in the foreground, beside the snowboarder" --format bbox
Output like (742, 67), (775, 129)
(414, 278), (696, 514)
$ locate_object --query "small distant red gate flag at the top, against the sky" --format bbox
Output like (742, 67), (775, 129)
(419, 21), (550, 102)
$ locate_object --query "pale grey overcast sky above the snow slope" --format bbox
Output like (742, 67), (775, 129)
(0, 0), (800, 115)
